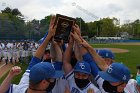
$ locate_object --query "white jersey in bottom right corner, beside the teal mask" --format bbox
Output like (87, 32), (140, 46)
(124, 79), (140, 93)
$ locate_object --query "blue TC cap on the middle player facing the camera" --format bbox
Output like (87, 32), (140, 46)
(74, 61), (91, 74)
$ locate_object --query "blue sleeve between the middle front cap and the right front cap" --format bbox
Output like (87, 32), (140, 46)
(83, 53), (100, 77)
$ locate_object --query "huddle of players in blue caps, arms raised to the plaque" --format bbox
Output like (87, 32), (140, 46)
(0, 16), (140, 93)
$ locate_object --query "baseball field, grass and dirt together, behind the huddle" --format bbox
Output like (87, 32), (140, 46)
(0, 43), (140, 84)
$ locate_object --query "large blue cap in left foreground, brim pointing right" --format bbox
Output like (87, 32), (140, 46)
(29, 62), (63, 82)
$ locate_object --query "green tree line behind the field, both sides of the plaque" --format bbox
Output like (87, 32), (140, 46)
(0, 7), (140, 40)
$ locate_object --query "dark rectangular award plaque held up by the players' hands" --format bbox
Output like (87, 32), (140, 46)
(54, 14), (76, 43)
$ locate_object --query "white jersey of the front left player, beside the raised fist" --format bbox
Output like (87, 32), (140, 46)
(6, 72), (29, 93)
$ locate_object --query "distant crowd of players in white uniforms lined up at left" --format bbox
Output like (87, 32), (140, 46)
(0, 41), (39, 64)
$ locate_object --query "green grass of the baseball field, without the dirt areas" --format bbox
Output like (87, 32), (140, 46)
(0, 44), (140, 84)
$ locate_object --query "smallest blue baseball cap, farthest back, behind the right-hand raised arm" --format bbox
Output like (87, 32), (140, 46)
(96, 49), (115, 60)
